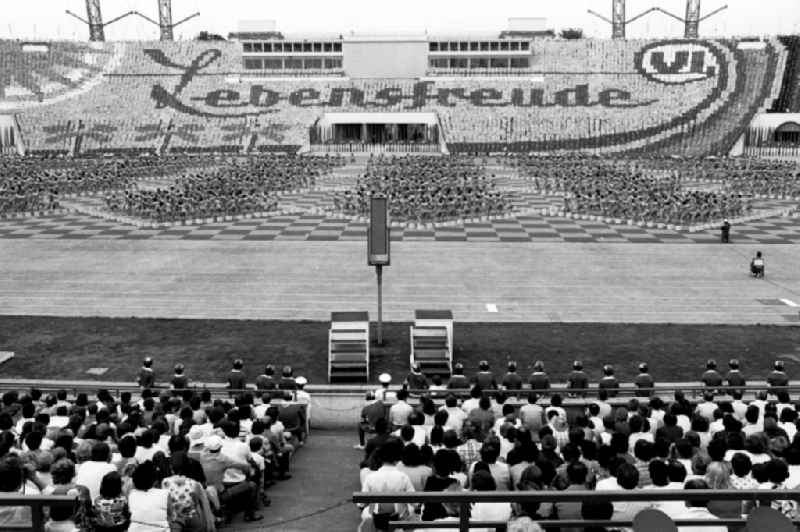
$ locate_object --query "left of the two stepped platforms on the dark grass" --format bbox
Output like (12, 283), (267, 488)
(328, 312), (369, 382)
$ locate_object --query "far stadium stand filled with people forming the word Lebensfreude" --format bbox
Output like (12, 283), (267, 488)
(3, 38), (797, 155)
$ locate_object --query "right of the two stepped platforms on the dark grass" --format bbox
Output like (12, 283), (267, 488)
(409, 310), (453, 377)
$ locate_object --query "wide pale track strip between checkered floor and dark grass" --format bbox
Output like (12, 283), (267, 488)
(0, 239), (800, 324)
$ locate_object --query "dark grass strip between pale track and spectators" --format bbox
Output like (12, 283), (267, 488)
(0, 316), (800, 384)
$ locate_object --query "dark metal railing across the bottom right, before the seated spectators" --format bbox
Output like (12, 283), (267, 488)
(353, 489), (800, 532)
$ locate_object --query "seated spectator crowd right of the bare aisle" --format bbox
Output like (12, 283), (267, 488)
(357, 360), (800, 532)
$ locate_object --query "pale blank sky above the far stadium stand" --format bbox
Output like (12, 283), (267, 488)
(0, 0), (800, 40)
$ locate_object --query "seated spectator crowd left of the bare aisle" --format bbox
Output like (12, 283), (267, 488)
(0, 359), (309, 532)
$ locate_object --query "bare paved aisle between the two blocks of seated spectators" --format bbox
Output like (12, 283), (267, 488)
(228, 431), (362, 532)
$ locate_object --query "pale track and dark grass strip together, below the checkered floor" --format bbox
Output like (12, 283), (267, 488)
(0, 239), (800, 383)
